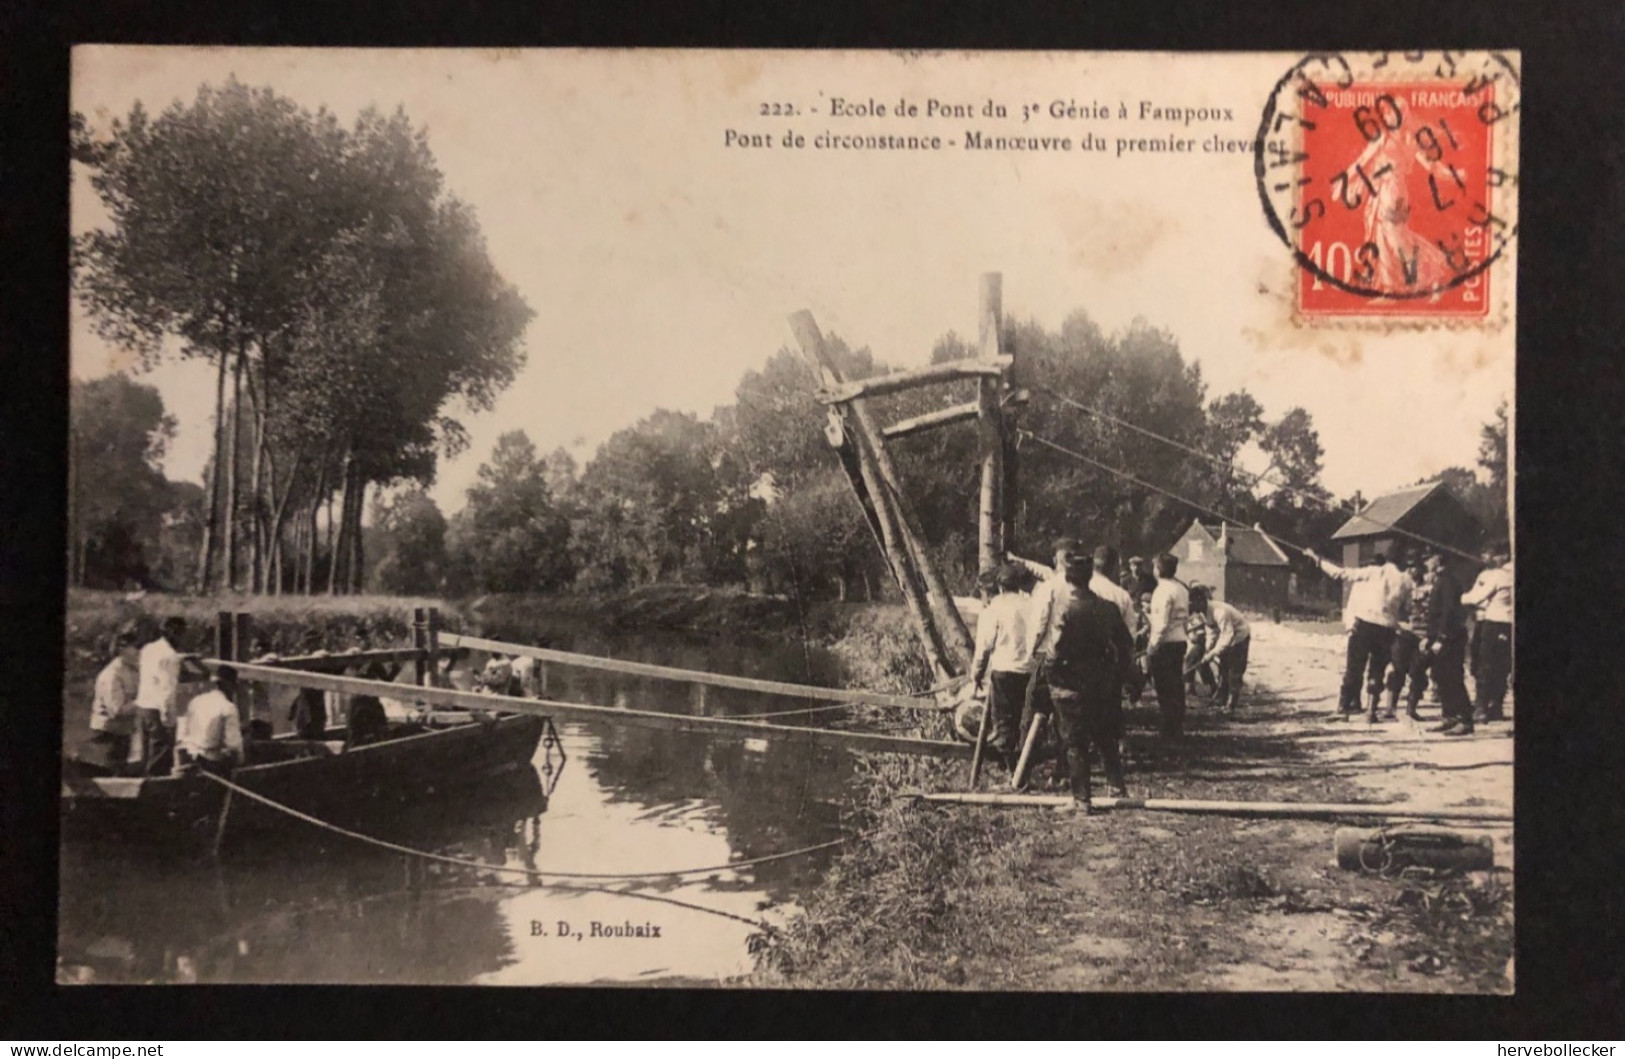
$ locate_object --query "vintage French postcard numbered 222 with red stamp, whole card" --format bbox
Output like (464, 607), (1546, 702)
(57, 41), (1521, 994)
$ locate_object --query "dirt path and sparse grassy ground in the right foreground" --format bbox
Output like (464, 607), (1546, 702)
(964, 622), (1513, 992)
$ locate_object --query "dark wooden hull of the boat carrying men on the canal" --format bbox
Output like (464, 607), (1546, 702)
(62, 715), (548, 836)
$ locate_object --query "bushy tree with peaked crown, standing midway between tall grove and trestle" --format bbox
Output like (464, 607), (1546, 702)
(449, 430), (574, 593)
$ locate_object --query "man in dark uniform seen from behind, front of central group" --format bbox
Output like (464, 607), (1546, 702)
(1040, 557), (1134, 810)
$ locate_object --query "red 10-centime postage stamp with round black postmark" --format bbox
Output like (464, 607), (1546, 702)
(1255, 52), (1519, 322)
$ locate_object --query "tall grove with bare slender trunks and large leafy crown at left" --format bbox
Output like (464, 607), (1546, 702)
(73, 80), (531, 591)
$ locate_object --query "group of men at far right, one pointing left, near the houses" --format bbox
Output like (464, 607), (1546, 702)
(1320, 542), (1513, 736)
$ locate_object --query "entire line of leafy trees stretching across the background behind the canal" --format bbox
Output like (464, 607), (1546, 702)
(70, 81), (1506, 598)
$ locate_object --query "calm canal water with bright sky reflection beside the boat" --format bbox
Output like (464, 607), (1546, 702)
(59, 635), (852, 986)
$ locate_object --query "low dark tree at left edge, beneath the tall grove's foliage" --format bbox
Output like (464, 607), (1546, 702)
(68, 375), (176, 586)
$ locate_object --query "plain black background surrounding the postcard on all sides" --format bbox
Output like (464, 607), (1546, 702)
(0, 0), (1625, 1041)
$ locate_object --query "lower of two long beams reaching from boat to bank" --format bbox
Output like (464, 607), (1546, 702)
(203, 658), (970, 759)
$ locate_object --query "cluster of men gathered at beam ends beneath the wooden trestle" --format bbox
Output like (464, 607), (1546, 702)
(970, 538), (1250, 810)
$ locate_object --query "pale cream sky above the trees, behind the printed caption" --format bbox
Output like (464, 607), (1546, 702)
(70, 47), (1513, 512)
